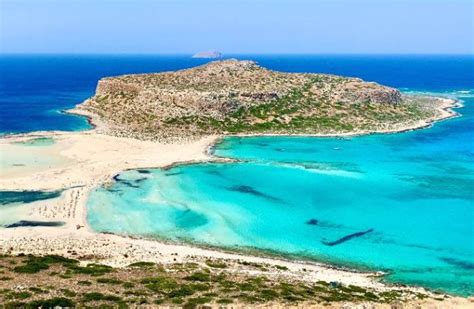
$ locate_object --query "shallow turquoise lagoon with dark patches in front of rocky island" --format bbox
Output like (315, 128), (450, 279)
(88, 92), (474, 295)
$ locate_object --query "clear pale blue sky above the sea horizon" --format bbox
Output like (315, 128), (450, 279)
(0, 0), (474, 54)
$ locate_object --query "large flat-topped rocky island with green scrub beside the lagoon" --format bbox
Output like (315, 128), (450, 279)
(77, 59), (452, 140)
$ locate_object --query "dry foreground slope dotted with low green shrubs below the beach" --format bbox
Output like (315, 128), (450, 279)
(0, 255), (443, 308)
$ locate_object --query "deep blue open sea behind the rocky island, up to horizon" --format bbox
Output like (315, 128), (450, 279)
(0, 55), (474, 134)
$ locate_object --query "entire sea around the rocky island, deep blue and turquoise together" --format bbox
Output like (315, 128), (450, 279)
(0, 55), (474, 295)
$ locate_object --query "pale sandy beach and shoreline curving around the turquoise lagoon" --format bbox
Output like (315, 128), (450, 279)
(0, 94), (468, 304)
